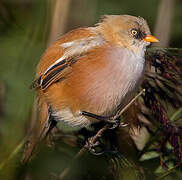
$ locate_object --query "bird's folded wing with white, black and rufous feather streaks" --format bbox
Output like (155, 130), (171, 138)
(31, 32), (104, 90)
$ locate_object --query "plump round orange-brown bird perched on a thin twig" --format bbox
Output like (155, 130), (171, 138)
(32, 15), (159, 136)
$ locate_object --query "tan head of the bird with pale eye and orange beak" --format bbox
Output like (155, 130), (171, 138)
(97, 15), (159, 53)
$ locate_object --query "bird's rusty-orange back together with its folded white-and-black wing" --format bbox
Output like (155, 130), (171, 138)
(31, 28), (103, 90)
